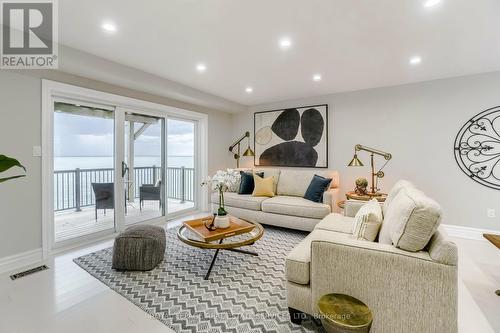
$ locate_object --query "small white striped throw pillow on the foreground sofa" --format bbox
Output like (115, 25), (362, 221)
(352, 199), (382, 242)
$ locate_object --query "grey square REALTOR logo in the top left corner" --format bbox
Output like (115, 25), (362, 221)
(0, 0), (58, 69)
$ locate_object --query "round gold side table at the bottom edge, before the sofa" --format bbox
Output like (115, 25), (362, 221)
(318, 294), (373, 333)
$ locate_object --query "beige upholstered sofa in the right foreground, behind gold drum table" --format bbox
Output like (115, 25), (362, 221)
(286, 184), (457, 333)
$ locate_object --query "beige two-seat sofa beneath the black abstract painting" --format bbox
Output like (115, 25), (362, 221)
(211, 168), (339, 231)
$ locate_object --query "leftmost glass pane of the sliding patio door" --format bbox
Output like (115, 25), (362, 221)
(53, 102), (115, 243)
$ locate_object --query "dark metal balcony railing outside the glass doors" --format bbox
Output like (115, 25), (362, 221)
(54, 166), (194, 211)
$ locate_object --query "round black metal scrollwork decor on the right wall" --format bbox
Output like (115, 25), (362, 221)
(455, 106), (500, 190)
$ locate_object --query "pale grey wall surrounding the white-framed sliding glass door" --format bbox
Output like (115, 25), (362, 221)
(0, 70), (233, 261)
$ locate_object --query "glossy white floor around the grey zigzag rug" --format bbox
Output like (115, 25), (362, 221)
(0, 215), (500, 333)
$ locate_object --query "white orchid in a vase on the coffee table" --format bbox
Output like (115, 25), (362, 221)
(201, 169), (241, 229)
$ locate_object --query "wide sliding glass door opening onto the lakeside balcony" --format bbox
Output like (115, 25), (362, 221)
(52, 100), (199, 247)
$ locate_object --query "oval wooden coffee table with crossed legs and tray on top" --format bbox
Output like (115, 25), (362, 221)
(177, 216), (264, 280)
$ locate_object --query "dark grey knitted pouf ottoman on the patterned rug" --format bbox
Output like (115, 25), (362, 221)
(112, 225), (166, 271)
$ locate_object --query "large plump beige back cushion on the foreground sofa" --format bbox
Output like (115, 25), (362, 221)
(384, 188), (442, 252)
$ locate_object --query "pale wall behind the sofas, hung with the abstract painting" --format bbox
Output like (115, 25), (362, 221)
(233, 72), (500, 230)
